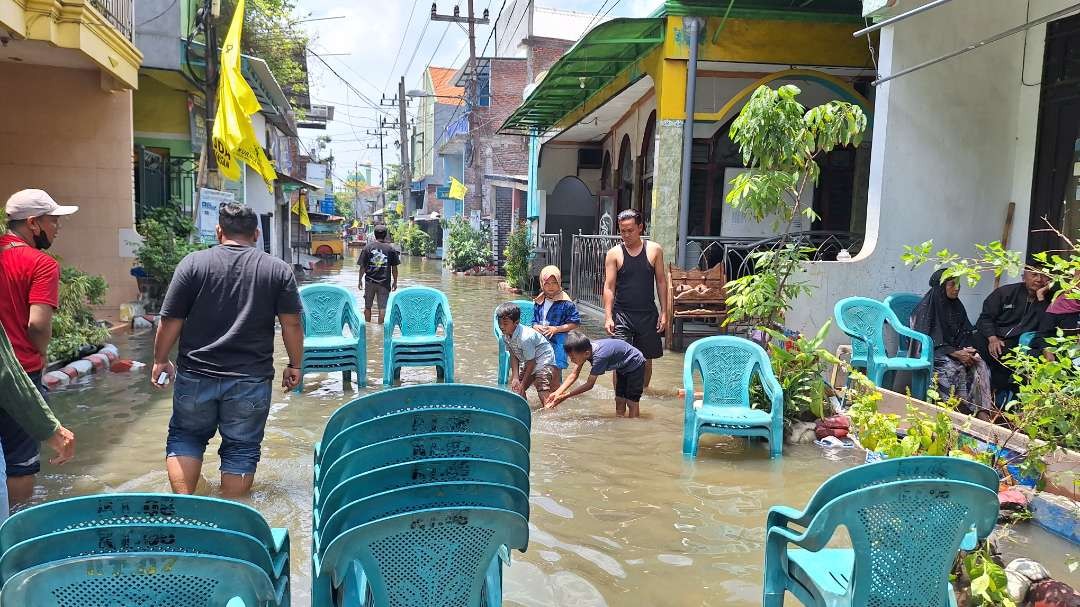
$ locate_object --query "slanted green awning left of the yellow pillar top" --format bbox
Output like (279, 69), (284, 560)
(499, 18), (664, 135)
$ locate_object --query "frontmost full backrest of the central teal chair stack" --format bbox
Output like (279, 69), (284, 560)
(314, 509), (528, 607)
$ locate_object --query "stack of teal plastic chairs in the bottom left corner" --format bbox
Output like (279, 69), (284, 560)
(0, 494), (289, 607)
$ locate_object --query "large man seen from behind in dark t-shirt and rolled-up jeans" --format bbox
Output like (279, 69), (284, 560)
(150, 202), (303, 498)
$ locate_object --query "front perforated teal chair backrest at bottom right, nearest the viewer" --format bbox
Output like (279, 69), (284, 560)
(808, 480), (998, 606)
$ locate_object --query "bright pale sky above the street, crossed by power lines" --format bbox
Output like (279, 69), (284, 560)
(297, 0), (661, 187)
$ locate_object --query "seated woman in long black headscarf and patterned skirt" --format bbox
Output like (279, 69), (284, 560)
(912, 269), (996, 420)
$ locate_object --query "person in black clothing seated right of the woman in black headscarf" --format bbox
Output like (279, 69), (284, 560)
(975, 265), (1050, 391)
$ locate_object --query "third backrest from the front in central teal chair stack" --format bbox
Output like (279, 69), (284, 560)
(315, 459), (529, 528)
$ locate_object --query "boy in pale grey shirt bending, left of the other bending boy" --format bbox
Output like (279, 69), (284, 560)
(495, 302), (555, 404)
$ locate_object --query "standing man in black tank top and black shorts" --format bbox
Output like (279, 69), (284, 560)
(604, 210), (667, 387)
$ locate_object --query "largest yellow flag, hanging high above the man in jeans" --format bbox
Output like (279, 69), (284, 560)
(214, 0), (276, 191)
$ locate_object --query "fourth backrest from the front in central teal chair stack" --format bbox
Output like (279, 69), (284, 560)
(315, 432), (529, 501)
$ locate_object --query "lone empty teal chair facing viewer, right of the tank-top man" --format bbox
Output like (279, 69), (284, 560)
(683, 335), (784, 457)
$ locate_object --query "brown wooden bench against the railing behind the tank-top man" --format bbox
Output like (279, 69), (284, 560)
(666, 264), (728, 352)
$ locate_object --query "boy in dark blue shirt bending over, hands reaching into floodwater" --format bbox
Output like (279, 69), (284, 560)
(544, 331), (645, 417)
